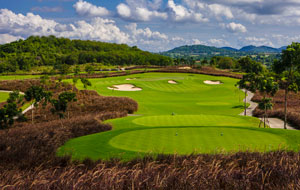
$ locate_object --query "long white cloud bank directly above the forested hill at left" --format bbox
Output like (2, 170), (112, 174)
(0, 9), (129, 43)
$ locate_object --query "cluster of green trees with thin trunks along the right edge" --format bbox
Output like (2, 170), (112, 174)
(237, 42), (300, 129)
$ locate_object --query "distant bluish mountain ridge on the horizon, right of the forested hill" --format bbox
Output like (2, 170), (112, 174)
(164, 45), (286, 54)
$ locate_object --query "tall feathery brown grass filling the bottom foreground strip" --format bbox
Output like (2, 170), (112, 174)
(0, 152), (300, 190)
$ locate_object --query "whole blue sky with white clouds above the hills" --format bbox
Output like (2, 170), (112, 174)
(0, 0), (300, 52)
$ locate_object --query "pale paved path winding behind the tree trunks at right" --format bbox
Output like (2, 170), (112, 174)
(240, 90), (297, 130)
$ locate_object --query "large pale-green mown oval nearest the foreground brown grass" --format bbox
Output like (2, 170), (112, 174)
(110, 127), (286, 154)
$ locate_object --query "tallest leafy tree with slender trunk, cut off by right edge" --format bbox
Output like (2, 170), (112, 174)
(272, 43), (300, 129)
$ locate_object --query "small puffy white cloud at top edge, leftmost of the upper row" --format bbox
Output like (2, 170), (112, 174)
(73, 0), (110, 17)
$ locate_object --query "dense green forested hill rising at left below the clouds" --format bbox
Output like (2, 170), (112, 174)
(0, 36), (172, 72)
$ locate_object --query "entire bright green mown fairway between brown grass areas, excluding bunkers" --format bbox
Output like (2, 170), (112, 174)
(57, 73), (300, 160)
